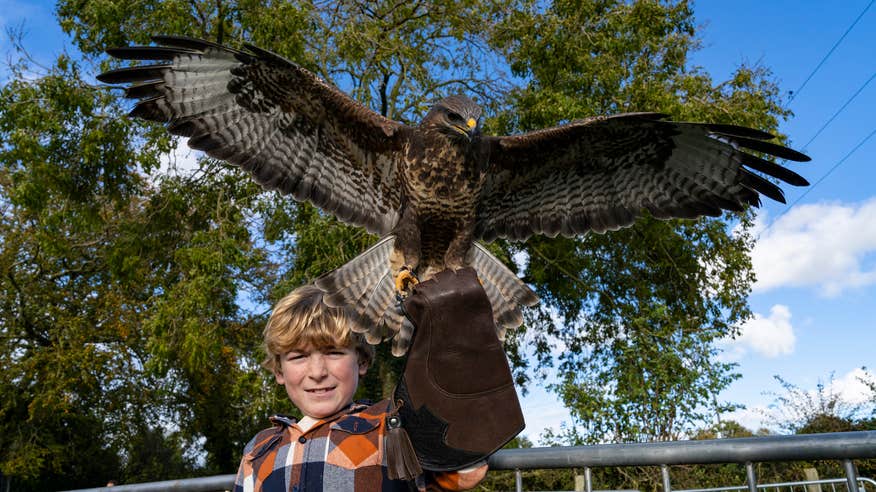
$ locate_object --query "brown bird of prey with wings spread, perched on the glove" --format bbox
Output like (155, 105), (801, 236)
(98, 36), (809, 355)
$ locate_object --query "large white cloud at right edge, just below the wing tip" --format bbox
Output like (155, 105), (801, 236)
(751, 198), (876, 296)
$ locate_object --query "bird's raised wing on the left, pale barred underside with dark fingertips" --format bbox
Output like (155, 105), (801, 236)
(97, 36), (410, 234)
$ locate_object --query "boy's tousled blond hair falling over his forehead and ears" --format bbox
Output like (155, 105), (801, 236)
(262, 284), (374, 374)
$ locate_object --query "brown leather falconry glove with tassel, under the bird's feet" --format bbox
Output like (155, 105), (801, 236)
(387, 268), (524, 478)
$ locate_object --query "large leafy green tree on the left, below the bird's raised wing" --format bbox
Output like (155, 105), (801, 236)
(0, 45), (267, 484)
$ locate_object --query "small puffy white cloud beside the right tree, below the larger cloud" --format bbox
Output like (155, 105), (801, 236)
(721, 304), (797, 360)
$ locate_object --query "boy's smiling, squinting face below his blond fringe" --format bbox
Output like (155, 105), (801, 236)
(274, 345), (368, 419)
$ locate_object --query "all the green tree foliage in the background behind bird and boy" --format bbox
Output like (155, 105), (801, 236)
(0, 0), (808, 490)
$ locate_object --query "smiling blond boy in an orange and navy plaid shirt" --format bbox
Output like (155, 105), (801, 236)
(234, 285), (487, 492)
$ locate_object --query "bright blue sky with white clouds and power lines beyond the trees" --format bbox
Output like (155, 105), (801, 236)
(0, 0), (876, 442)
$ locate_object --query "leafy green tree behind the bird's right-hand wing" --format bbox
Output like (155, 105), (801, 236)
(494, 0), (788, 443)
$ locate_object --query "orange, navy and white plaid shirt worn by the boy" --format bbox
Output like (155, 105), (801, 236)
(234, 400), (487, 492)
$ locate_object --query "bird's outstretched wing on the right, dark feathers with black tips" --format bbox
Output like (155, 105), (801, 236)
(475, 113), (809, 241)
